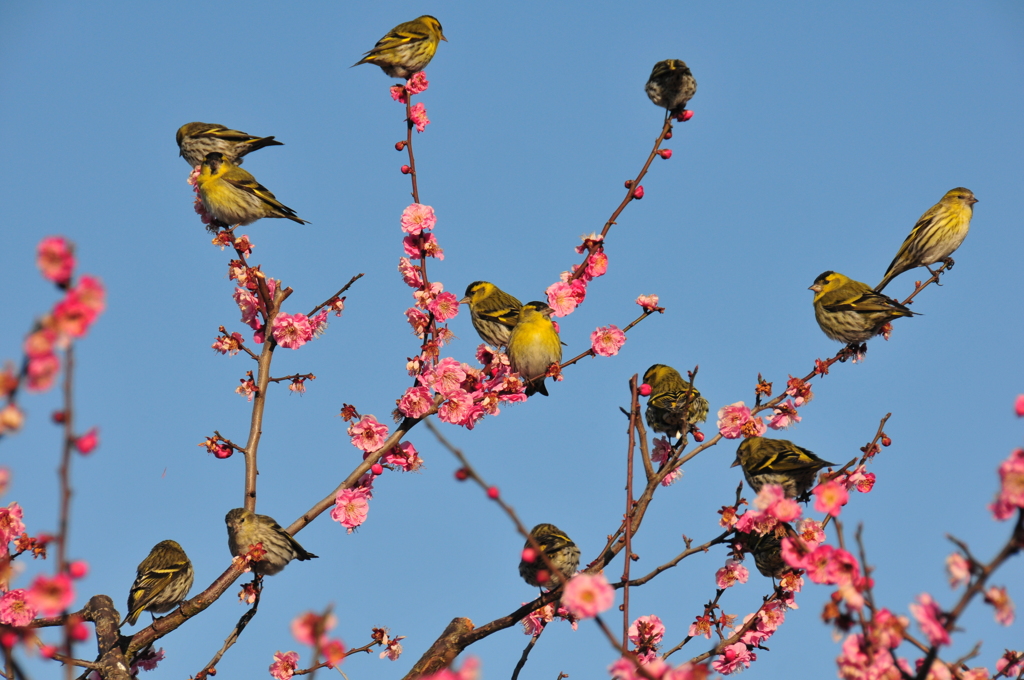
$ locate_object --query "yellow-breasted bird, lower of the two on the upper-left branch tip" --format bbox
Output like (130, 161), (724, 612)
(197, 152), (308, 226)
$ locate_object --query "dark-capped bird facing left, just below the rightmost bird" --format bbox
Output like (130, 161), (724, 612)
(808, 271), (916, 344)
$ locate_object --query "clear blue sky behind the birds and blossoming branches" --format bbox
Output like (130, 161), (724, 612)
(0, 1), (1024, 678)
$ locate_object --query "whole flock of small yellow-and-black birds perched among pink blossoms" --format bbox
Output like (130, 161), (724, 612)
(121, 15), (978, 626)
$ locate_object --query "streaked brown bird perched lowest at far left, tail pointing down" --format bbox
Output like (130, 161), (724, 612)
(118, 541), (196, 628)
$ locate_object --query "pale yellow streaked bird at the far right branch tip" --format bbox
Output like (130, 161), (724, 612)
(874, 186), (978, 293)
